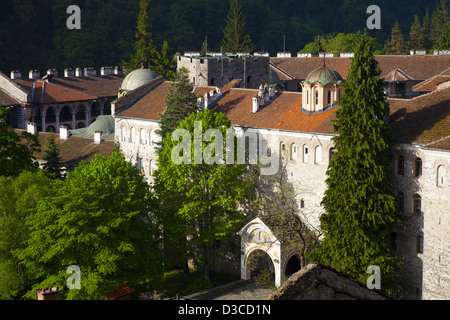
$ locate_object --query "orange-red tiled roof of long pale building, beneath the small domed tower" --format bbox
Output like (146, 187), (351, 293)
(118, 82), (450, 150)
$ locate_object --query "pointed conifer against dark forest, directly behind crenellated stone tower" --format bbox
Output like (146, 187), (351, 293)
(222, 0), (255, 53)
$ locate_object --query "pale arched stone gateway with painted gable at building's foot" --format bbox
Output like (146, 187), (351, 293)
(239, 218), (301, 287)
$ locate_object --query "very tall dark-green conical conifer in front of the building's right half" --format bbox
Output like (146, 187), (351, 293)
(310, 34), (401, 289)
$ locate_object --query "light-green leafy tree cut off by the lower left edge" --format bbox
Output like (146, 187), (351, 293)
(0, 171), (52, 300)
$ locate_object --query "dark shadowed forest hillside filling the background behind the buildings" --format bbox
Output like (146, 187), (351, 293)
(0, 0), (440, 74)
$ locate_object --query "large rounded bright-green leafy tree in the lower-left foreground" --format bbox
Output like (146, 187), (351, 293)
(16, 152), (162, 299)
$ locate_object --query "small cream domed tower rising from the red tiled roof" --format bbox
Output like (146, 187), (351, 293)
(302, 66), (344, 113)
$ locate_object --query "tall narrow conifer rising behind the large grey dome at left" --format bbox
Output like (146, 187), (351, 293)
(126, 0), (157, 72)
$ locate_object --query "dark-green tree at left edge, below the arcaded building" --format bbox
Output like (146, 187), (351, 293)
(0, 107), (40, 176)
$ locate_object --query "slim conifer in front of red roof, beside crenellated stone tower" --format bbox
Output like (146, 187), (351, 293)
(157, 68), (199, 148)
